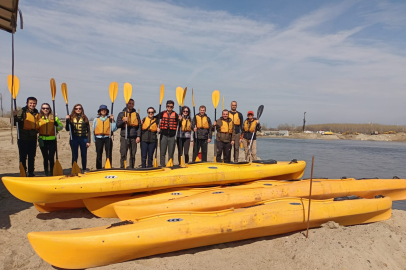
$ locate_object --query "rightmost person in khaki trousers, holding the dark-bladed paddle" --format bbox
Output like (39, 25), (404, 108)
(240, 111), (261, 161)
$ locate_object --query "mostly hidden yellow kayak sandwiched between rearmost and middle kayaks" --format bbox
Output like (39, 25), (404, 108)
(83, 180), (291, 218)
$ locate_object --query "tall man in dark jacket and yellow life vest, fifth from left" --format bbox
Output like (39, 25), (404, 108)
(117, 99), (141, 169)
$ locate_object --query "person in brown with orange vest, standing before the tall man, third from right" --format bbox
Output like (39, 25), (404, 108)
(214, 110), (235, 163)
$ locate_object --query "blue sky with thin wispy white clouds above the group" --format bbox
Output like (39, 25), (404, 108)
(0, 0), (406, 127)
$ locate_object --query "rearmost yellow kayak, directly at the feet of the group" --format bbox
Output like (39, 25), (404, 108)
(2, 161), (306, 203)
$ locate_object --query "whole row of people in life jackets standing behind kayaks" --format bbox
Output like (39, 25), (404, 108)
(14, 97), (261, 177)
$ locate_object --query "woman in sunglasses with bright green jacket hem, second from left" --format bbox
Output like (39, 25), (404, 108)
(37, 103), (63, 176)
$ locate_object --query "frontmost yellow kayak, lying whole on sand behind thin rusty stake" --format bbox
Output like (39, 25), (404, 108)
(28, 197), (392, 269)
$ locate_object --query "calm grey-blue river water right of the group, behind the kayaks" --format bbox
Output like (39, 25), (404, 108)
(257, 138), (406, 179)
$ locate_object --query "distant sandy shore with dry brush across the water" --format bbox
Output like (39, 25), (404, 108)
(260, 132), (406, 142)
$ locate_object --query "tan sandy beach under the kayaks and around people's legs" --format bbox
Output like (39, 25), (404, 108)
(0, 127), (406, 270)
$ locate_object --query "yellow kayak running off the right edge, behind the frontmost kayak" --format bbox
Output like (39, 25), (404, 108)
(114, 178), (406, 220)
